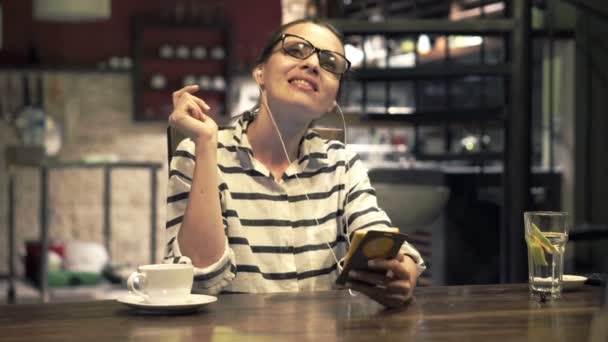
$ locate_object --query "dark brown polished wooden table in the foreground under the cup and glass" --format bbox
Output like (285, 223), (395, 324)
(0, 285), (601, 342)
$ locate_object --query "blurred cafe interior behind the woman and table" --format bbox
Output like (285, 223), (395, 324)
(0, 0), (608, 299)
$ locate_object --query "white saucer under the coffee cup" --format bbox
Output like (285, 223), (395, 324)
(117, 294), (217, 314)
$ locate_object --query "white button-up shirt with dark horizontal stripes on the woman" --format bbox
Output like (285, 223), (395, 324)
(165, 114), (425, 294)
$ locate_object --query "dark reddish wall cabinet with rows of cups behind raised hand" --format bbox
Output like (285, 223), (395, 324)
(132, 17), (230, 121)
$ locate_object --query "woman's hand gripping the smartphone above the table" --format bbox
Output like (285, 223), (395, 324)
(347, 253), (418, 308)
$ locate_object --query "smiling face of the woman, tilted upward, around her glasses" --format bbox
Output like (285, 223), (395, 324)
(254, 23), (344, 120)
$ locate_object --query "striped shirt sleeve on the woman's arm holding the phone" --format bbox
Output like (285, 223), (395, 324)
(344, 148), (426, 275)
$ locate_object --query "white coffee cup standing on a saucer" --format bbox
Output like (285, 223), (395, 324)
(127, 264), (194, 304)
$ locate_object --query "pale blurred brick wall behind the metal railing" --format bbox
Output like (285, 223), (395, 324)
(0, 72), (167, 273)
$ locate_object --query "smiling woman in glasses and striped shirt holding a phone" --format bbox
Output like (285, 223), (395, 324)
(166, 20), (425, 307)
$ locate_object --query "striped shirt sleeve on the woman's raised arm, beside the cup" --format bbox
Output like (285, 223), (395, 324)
(164, 139), (236, 294)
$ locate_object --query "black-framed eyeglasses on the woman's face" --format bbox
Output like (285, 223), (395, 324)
(277, 33), (350, 75)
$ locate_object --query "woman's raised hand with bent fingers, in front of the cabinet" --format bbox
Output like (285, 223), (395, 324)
(169, 85), (217, 144)
